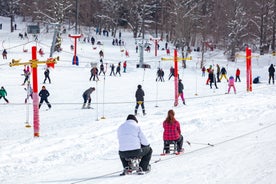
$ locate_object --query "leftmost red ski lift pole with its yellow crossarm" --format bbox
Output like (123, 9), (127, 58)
(10, 46), (59, 137)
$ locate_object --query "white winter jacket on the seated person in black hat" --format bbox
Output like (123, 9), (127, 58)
(117, 120), (149, 151)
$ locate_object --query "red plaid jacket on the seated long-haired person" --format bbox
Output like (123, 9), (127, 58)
(163, 120), (181, 141)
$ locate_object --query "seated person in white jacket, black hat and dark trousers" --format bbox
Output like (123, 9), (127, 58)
(117, 114), (152, 172)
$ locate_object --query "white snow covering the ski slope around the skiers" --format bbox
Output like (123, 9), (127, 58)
(0, 17), (276, 184)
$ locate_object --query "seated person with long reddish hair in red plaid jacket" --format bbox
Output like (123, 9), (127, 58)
(163, 109), (184, 154)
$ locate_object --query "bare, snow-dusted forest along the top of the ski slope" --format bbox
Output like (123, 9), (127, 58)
(0, 0), (276, 59)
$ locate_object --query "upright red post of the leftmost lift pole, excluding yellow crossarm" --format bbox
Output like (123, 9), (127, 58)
(31, 46), (39, 137)
